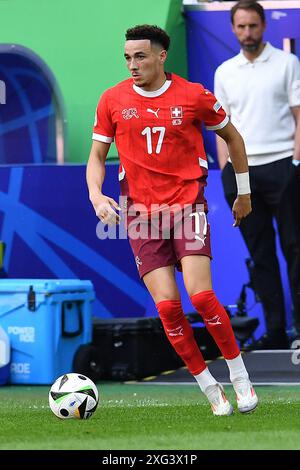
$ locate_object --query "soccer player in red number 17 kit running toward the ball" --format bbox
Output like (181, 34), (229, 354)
(87, 25), (258, 415)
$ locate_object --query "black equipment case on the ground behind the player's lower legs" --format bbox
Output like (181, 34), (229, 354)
(73, 314), (221, 381)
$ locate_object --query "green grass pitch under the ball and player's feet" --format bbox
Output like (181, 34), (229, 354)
(0, 383), (300, 450)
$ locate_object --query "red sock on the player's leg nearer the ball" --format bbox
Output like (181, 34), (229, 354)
(156, 300), (206, 375)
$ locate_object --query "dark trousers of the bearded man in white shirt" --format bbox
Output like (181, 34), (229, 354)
(222, 158), (300, 335)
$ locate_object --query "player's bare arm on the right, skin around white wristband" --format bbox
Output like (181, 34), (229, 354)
(216, 122), (251, 227)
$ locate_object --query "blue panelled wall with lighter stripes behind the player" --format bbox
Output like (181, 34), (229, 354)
(0, 164), (290, 342)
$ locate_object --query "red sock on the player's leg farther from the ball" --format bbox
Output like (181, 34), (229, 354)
(191, 290), (240, 359)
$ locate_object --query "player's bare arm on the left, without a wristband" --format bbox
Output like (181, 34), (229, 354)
(86, 140), (120, 225)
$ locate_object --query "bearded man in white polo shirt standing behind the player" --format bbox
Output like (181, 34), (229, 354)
(215, 1), (300, 349)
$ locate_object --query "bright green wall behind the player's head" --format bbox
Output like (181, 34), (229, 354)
(0, 0), (187, 162)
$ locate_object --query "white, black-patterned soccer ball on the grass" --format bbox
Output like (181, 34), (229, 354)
(49, 373), (99, 419)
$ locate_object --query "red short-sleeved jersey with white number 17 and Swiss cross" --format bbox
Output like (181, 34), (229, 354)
(93, 74), (228, 210)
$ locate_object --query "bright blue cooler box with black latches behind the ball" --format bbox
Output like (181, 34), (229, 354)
(0, 279), (95, 384)
